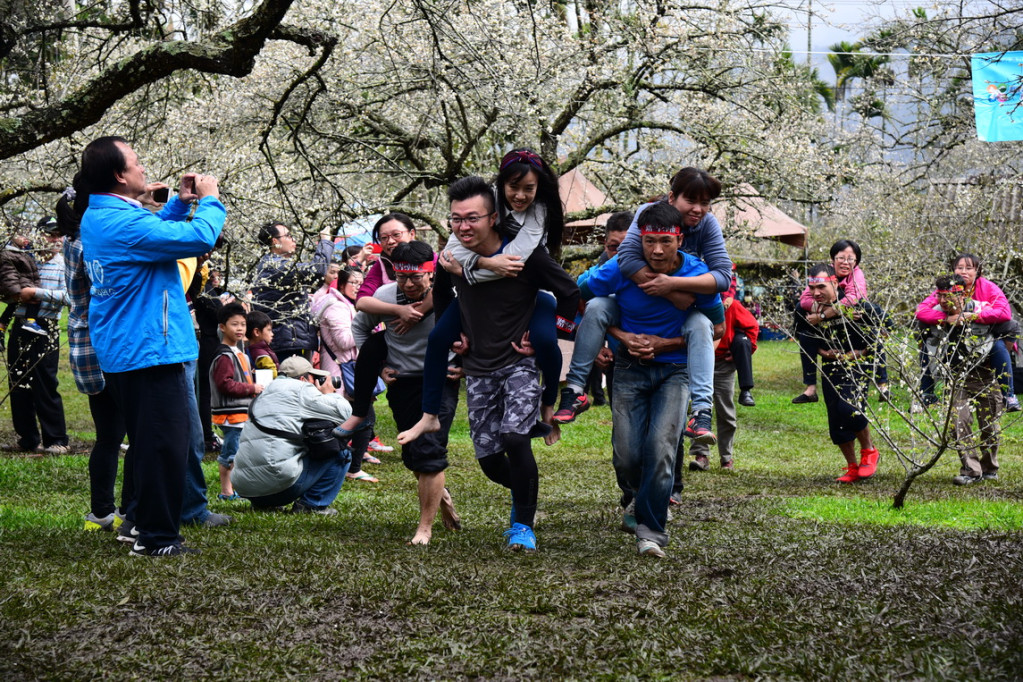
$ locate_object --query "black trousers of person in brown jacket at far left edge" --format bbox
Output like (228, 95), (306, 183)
(7, 318), (68, 450)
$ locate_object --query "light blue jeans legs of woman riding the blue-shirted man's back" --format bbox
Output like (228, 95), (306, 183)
(565, 297), (714, 413)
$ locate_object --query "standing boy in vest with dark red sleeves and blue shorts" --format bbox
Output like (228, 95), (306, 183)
(210, 303), (269, 500)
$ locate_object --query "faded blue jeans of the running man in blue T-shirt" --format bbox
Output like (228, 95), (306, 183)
(611, 352), (688, 547)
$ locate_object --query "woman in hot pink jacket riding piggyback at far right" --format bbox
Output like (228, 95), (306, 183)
(917, 254), (1020, 412)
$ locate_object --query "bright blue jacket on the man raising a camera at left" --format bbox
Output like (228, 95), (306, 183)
(82, 194), (227, 372)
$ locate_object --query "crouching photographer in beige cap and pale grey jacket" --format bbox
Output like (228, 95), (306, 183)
(231, 356), (352, 515)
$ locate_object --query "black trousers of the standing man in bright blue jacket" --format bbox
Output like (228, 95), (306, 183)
(106, 364), (192, 549)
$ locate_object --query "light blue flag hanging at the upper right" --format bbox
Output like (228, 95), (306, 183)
(971, 52), (1023, 142)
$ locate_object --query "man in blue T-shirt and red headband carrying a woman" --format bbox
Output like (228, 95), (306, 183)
(581, 203), (724, 557)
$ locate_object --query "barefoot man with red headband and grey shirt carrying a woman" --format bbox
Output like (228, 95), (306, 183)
(352, 241), (461, 545)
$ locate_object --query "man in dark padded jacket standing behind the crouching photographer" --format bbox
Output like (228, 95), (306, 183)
(253, 222), (333, 361)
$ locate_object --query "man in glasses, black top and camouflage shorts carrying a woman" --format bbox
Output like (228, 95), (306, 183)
(427, 177), (579, 551)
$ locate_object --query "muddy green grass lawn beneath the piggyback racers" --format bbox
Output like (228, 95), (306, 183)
(0, 343), (1023, 680)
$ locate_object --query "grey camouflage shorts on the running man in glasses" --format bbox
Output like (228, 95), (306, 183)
(465, 358), (540, 459)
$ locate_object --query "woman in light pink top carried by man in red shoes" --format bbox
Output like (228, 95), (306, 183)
(792, 239), (888, 405)
